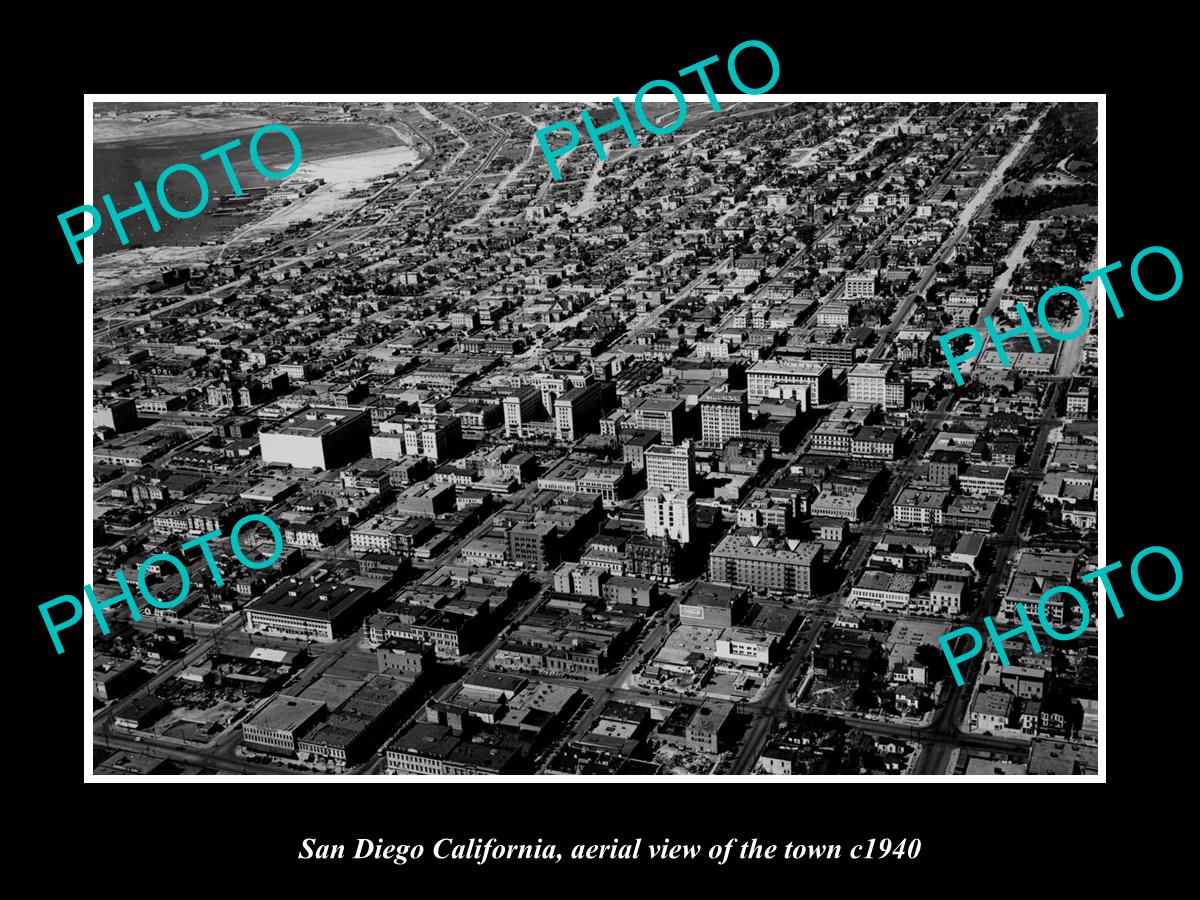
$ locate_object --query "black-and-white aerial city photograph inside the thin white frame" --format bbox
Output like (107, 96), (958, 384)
(87, 95), (1105, 780)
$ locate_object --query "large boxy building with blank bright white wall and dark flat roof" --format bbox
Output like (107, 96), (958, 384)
(258, 407), (371, 469)
